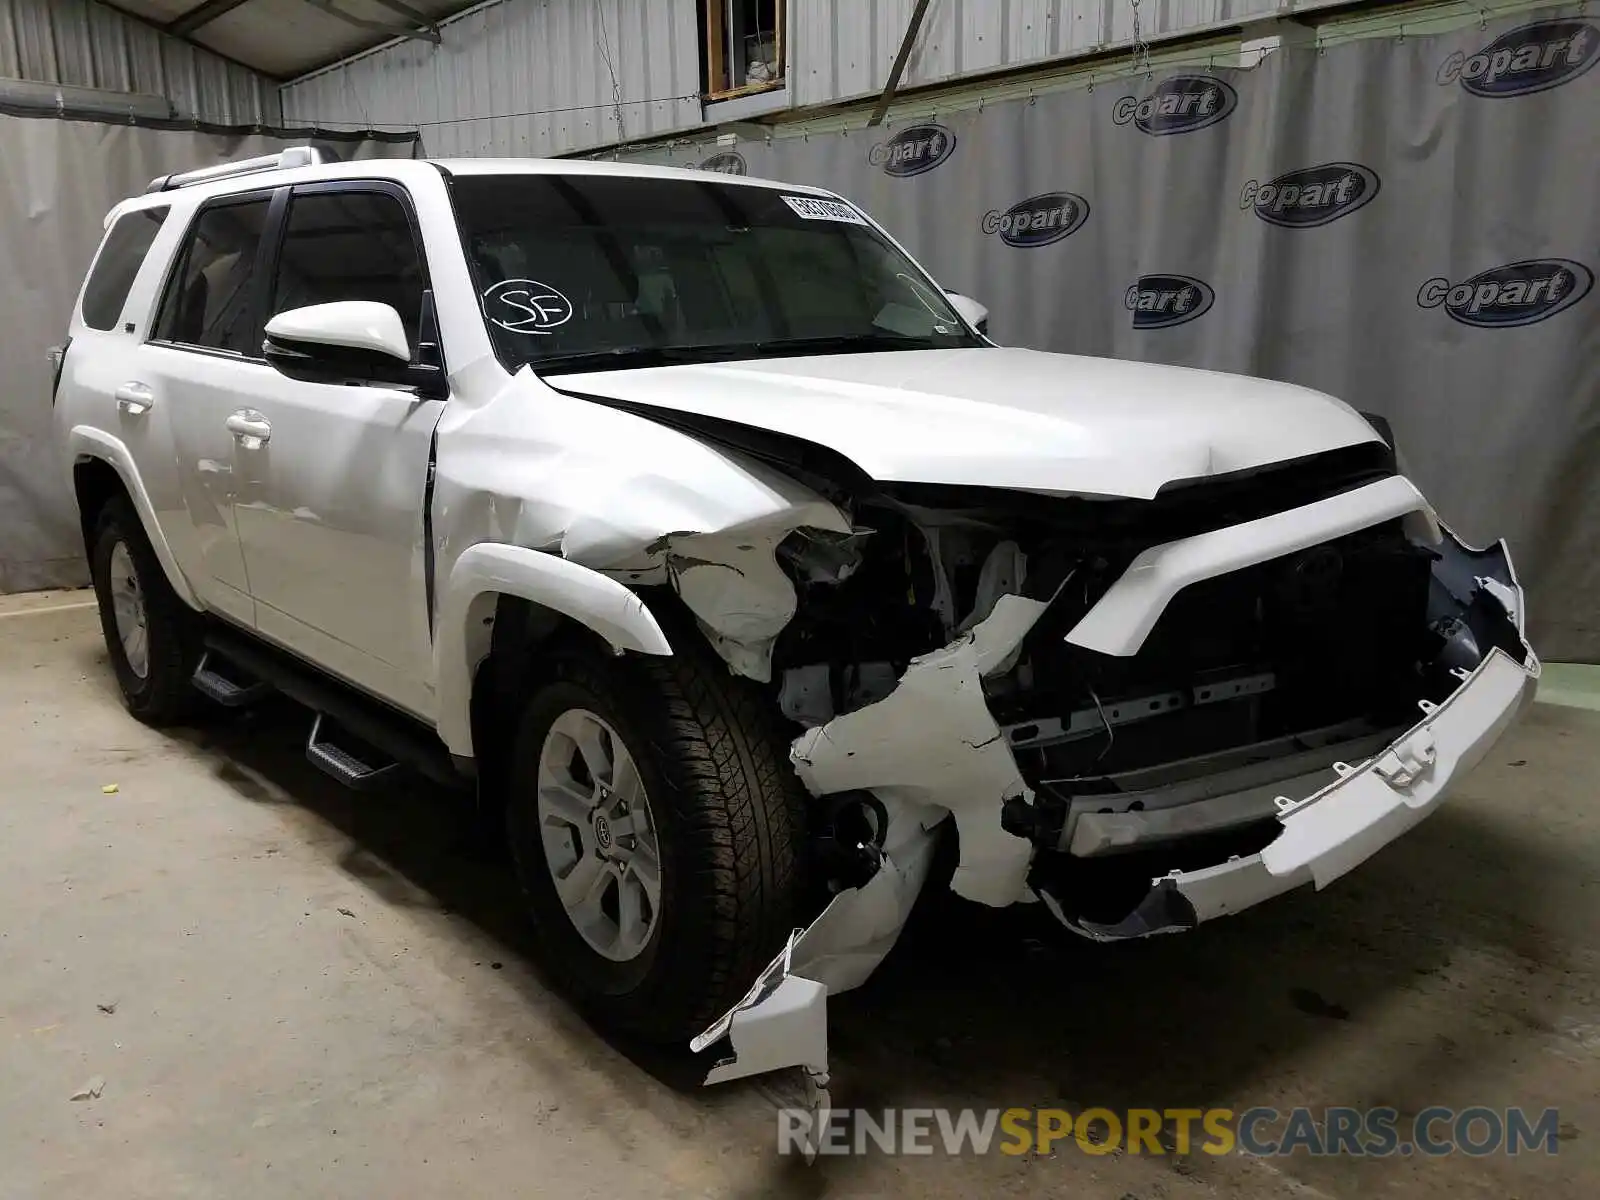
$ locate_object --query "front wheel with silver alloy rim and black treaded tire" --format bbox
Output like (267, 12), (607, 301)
(507, 654), (805, 1042)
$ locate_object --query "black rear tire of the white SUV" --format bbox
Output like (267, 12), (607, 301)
(90, 496), (202, 725)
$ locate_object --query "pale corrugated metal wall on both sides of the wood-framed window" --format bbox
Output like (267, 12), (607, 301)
(283, 0), (1376, 155)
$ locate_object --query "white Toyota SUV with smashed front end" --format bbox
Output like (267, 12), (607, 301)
(53, 147), (1539, 1094)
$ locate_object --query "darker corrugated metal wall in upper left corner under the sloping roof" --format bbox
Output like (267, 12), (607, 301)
(0, 0), (280, 125)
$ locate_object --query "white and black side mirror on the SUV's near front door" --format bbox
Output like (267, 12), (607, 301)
(264, 301), (445, 397)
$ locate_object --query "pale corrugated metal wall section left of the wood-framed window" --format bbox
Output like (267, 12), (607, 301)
(283, 0), (701, 157)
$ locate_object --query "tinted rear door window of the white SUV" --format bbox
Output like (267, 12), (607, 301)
(155, 197), (269, 357)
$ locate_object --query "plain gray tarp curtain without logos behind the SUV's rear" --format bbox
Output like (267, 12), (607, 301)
(0, 114), (414, 592)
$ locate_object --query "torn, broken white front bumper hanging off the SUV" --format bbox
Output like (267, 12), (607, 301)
(693, 514), (1541, 1109)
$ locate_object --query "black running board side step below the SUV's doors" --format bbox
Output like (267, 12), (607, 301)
(196, 624), (472, 789)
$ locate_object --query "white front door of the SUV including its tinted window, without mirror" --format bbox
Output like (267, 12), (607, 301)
(237, 181), (443, 717)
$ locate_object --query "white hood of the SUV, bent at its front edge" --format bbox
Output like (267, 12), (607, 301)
(544, 349), (1378, 499)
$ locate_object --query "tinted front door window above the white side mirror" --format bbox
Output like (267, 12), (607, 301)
(269, 190), (427, 354)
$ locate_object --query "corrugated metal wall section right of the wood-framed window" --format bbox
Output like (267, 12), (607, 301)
(790, 0), (1350, 107)
